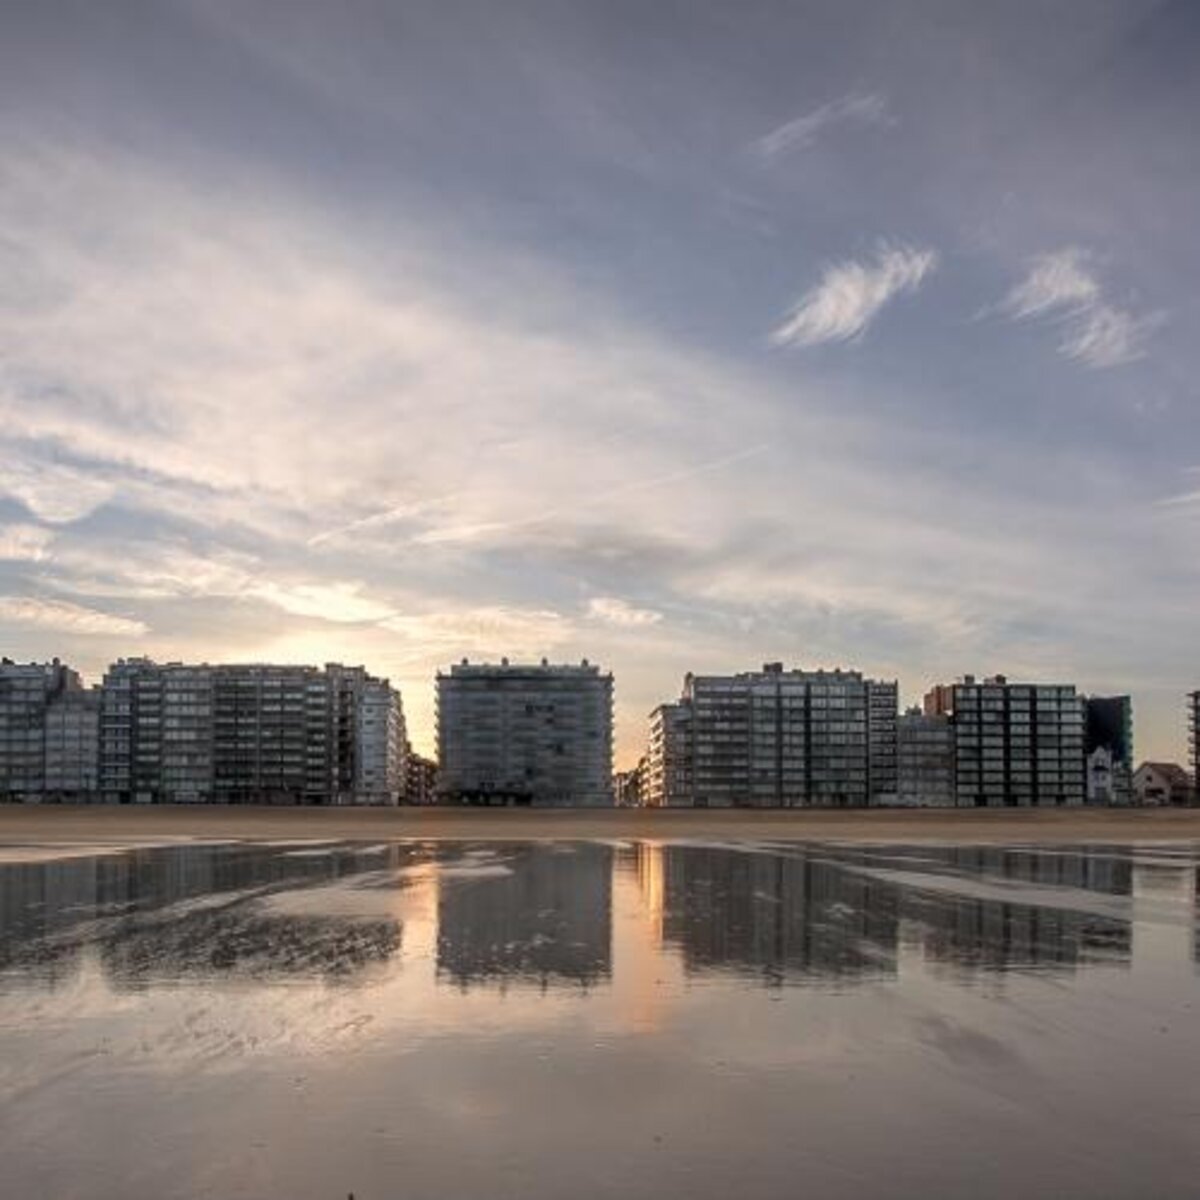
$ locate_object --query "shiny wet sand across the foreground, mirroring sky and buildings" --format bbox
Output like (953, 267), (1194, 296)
(0, 842), (1200, 1200)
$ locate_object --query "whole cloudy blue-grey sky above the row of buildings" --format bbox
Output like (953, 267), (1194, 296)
(0, 0), (1200, 766)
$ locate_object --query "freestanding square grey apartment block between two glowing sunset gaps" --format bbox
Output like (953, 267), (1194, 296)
(437, 659), (612, 805)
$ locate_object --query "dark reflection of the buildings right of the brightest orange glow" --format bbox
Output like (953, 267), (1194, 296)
(640, 846), (1132, 984)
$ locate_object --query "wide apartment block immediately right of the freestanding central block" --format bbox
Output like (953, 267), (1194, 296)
(647, 662), (898, 808)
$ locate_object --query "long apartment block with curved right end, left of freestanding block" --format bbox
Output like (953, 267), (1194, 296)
(100, 659), (404, 804)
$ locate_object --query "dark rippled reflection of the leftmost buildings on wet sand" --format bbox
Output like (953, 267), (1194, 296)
(0, 846), (410, 990)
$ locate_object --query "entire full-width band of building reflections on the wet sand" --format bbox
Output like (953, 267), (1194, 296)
(0, 844), (1200, 1003)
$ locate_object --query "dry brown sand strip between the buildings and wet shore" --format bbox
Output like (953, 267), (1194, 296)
(0, 805), (1200, 850)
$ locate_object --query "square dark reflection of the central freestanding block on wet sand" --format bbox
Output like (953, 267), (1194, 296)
(438, 844), (613, 988)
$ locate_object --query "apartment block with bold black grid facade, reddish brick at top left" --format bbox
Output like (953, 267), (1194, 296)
(925, 676), (1086, 808)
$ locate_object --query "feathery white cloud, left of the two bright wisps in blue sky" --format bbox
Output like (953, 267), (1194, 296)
(770, 244), (937, 346)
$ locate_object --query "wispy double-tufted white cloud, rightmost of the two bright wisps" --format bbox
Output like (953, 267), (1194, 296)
(1000, 246), (1165, 368)
